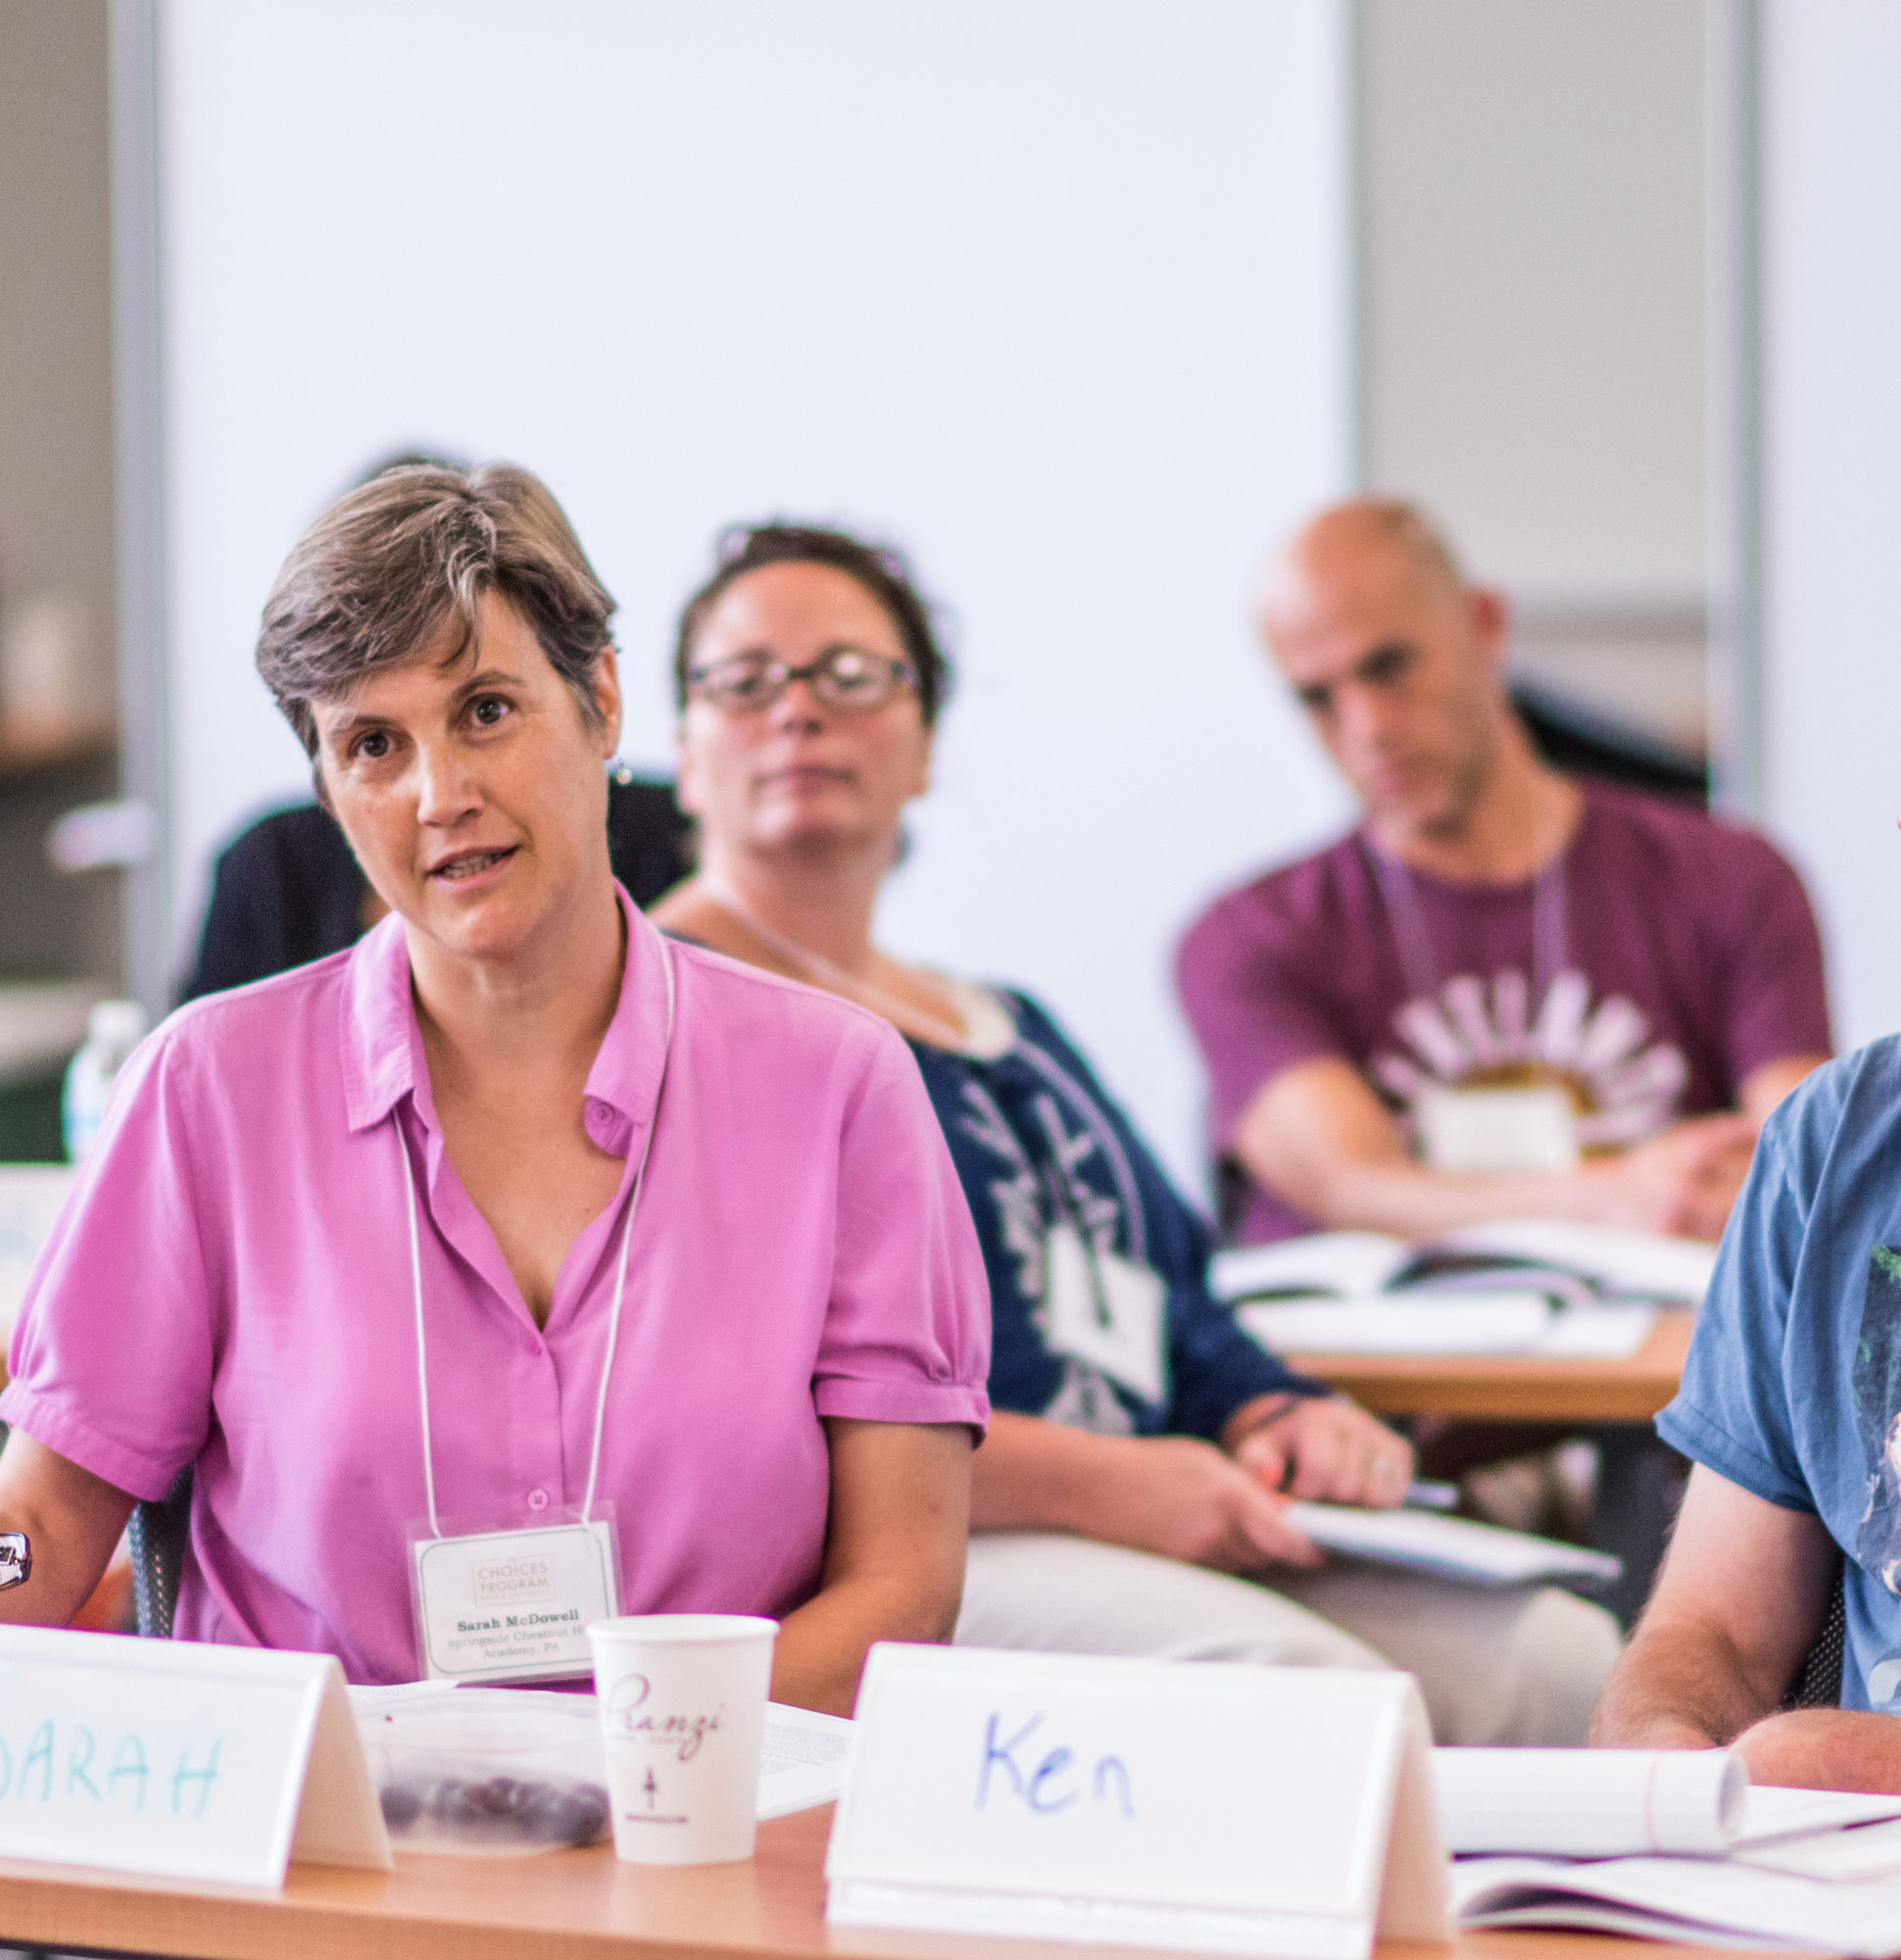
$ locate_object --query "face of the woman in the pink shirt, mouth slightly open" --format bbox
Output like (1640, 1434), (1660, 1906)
(312, 592), (621, 962)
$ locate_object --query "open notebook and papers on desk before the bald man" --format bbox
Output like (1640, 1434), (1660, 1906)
(1209, 1219), (1715, 1360)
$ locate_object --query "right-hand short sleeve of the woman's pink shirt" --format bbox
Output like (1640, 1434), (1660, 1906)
(813, 1029), (990, 1431)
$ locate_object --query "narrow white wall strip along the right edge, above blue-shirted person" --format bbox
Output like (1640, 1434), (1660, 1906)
(1762, 0), (1901, 1047)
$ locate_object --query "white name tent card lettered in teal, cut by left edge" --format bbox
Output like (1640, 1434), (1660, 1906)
(0, 1627), (392, 1886)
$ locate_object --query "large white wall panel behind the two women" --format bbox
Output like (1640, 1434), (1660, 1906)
(161, 0), (1348, 1176)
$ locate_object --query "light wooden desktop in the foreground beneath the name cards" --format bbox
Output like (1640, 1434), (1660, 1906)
(0, 1805), (1787, 1960)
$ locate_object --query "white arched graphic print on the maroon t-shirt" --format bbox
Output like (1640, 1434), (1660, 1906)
(1366, 968), (1689, 1151)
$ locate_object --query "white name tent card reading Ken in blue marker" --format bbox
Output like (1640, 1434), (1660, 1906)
(825, 1644), (1450, 1960)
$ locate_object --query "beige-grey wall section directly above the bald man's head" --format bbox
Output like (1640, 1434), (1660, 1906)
(1358, 0), (1705, 600)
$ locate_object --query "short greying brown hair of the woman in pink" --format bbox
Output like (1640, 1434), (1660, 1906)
(257, 463), (615, 757)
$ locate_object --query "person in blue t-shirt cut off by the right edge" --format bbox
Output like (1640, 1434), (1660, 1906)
(1593, 1035), (1901, 1791)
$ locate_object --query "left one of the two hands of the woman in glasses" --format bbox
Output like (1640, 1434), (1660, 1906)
(1099, 1437), (1323, 1572)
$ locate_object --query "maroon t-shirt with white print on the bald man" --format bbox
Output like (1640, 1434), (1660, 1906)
(1176, 782), (1828, 1243)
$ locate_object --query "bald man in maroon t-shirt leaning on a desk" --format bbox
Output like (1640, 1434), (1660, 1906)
(1178, 498), (1828, 1243)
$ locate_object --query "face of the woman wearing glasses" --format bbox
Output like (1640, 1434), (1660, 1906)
(680, 564), (931, 853)
